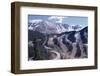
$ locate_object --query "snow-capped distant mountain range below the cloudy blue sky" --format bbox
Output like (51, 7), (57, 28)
(28, 20), (84, 34)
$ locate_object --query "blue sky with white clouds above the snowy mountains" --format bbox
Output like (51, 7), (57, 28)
(28, 15), (88, 27)
